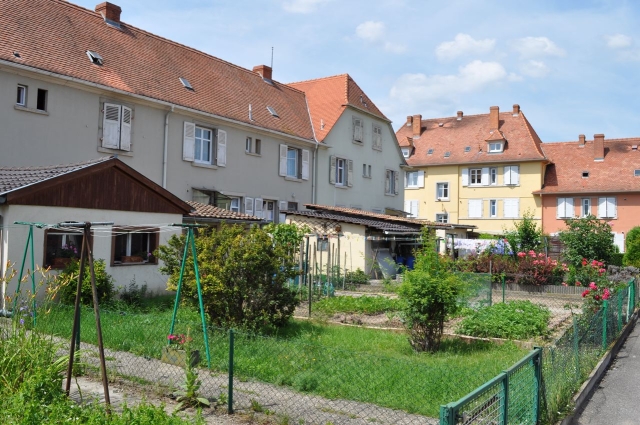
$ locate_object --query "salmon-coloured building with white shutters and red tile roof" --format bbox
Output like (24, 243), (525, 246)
(534, 134), (640, 252)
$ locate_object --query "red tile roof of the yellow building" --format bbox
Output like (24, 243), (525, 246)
(396, 106), (545, 166)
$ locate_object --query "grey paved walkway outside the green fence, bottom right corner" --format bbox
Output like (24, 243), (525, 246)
(574, 323), (640, 425)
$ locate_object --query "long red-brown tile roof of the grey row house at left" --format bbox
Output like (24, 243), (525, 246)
(0, 0), (313, 140)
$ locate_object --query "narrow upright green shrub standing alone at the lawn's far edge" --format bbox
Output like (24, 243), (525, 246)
(398, 230), (465, 352)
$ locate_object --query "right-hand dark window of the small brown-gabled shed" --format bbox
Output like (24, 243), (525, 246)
(111, 226), (159, 265)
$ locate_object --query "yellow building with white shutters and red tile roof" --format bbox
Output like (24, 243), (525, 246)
(396, 105), (548, 234)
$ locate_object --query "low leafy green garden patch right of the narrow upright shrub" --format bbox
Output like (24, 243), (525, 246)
(456, 300), (551, 339)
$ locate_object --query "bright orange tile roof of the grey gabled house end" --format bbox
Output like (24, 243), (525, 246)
(288, 74), (389, 142)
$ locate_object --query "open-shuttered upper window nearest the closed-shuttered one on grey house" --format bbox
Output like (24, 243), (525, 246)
(182, 121), (227, 167)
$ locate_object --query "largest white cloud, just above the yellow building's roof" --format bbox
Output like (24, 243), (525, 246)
(390, 60), (510, 109)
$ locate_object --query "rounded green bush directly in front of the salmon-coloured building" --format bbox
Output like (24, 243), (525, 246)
(560, 215), (616, 267)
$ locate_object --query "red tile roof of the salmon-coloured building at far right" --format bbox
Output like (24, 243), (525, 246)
(536, 137), (640, 194)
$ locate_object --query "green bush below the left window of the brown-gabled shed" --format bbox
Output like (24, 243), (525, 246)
(56, 260), (115, 305)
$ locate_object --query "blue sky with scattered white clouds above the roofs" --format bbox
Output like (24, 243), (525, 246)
(71, 0), (640, 141)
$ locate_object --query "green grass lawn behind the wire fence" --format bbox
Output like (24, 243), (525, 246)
(38, 298), (526, 417)
